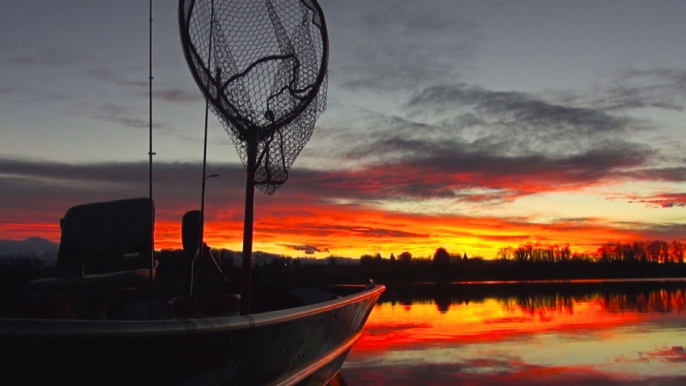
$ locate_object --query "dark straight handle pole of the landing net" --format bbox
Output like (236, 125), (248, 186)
(240, 138), (257, 315)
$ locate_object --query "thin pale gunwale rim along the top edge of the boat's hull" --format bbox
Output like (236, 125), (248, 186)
(0, 284), (386, 339)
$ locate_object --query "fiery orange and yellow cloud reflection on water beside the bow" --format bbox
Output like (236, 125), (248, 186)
(355, 299), (637, 356)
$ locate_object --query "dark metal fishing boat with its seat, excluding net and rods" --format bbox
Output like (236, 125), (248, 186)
(0, 198), (384, 385)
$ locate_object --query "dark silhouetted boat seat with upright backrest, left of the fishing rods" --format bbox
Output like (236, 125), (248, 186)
(26, 198), (157, 298)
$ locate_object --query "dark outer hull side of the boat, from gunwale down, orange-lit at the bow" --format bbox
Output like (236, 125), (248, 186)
(0, 286), (384, 385)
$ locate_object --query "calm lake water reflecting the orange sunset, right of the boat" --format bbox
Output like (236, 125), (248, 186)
(342, 280), (686, 386)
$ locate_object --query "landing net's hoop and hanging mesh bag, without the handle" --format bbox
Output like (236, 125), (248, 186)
(180, 0), (328, 194)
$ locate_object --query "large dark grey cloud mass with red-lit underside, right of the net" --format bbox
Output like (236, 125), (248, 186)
(294, 84), (668, 203)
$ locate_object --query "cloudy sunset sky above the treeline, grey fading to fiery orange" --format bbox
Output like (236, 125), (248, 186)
(0, 0), (686, 258)
